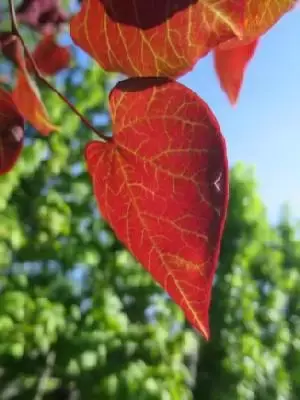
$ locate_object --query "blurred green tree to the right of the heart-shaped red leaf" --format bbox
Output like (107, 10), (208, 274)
(194, 166), (300, 400)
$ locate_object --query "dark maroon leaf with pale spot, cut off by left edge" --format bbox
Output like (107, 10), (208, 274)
(0, 88), (24, 175)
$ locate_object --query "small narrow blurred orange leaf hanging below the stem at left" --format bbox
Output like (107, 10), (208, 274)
(12, 70), (58, 135)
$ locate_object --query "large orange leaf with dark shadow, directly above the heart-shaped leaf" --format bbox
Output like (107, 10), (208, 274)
(70, 0), (244, 77)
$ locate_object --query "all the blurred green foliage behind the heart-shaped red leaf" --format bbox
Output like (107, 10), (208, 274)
(0, 2), (300, 400)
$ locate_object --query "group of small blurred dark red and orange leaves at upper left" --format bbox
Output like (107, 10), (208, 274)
(0, 0), (70, 170)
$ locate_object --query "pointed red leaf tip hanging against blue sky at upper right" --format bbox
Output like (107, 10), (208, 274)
(214, 40), (258, 104)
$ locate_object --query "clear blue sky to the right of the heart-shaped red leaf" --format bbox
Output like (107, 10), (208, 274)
(180, 9), (300, 221)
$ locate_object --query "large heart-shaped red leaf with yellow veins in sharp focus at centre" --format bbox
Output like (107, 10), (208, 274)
(85, 78), (228, 339)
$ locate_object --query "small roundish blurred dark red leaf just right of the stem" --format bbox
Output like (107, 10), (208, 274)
(32, 35), (71, 75)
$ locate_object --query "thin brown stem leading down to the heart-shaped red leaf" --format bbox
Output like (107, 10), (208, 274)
(9, 0), (109, 142)
